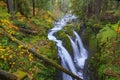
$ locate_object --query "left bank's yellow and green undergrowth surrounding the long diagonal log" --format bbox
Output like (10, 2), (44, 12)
(0, 1), (57, 80)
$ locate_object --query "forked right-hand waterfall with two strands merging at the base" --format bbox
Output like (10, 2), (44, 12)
(68, 31), (88, 78)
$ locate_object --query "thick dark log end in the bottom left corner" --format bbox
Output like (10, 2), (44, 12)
(0, 70), (17, 80)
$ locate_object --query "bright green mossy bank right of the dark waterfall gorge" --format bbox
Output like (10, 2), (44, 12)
(89, 23), (120, 80)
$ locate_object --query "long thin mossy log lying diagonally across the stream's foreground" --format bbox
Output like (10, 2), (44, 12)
(3, 27), (82, 80)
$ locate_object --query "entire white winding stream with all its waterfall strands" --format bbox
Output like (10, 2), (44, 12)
(48, 14), (87, 80)
